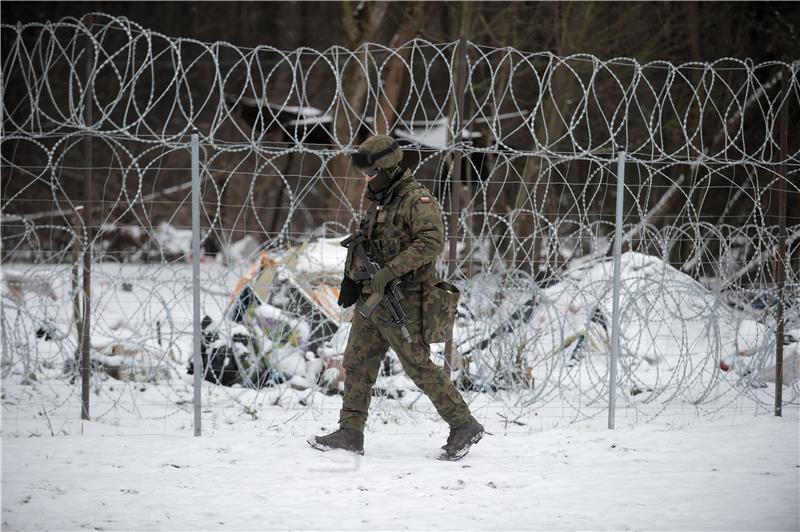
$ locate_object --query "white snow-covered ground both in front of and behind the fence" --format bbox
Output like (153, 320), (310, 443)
(2, 251), (800, 530)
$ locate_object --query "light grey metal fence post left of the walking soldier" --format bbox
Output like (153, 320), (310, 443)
(192, 133), (205, 436)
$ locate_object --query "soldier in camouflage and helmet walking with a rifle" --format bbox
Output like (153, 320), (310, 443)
(309, 135), (484, 460)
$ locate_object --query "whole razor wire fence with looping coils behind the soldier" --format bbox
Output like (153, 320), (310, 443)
(1, 13), (800, 433)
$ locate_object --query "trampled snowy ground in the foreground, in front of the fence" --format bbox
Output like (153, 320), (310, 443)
(2, 385), (800, 530)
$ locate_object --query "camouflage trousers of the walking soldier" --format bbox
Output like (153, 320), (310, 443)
(339, 291), (470, 431)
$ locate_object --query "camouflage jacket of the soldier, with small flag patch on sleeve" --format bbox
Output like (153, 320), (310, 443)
(345, 169), (444, 292)
